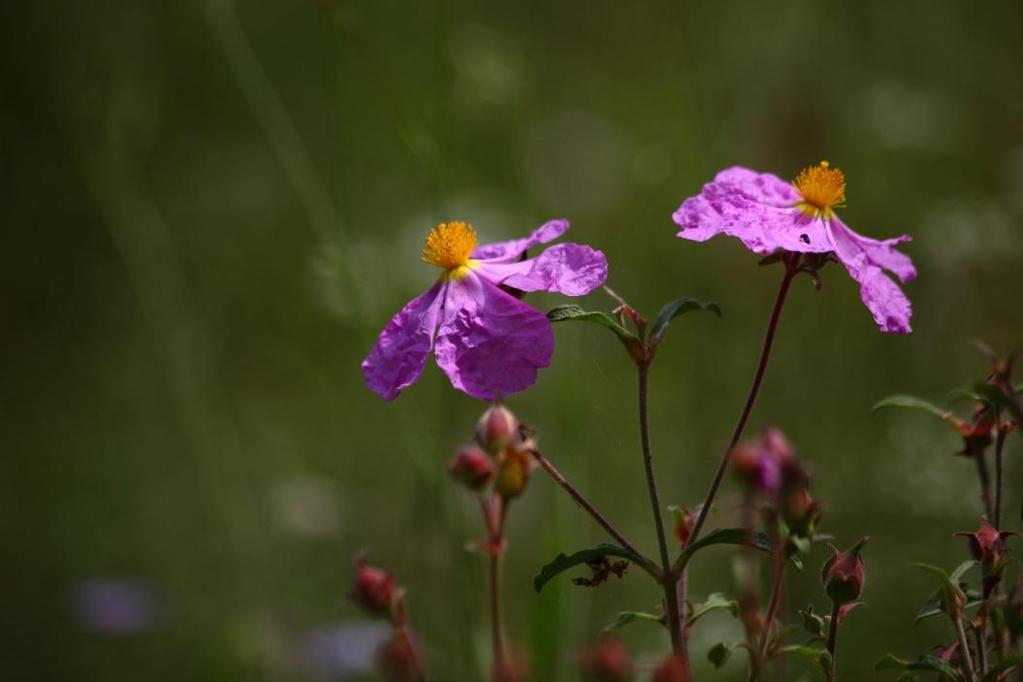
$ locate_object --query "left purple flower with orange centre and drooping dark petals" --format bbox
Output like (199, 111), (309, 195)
(362, 220), (608, 400)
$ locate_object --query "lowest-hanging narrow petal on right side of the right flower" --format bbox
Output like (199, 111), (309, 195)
(829, 220), (913, 334)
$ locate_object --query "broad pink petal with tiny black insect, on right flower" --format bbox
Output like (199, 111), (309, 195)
(672, 167), (832, 254)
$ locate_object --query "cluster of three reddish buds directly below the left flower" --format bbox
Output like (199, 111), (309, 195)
(448, 405), (535, 501)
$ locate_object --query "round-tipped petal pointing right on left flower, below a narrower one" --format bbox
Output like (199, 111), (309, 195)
(476, 242), (608, 295)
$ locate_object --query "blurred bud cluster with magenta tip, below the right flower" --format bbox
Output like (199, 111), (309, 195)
(731, 427), (820, 551)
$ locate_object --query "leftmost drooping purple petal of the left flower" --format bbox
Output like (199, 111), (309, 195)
(362, 281), (447, 400)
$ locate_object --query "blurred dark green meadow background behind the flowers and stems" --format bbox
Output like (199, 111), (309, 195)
(0, 0), (1023, 681)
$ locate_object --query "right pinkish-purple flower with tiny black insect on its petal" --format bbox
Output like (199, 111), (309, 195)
(672, 162), (917, 333)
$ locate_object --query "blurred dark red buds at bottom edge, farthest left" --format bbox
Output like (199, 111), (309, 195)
(349, 552), (424, 682)
